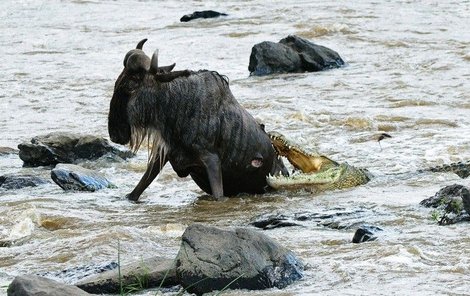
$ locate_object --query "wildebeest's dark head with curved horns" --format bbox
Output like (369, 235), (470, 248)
(108, 39), (175, 145)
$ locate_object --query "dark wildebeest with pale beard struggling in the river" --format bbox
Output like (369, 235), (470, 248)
(108, 39), (287, 201)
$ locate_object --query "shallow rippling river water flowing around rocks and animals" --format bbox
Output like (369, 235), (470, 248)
(0, 0), (470, 295)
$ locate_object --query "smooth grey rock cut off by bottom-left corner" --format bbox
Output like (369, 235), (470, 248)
(7, 275), (90, 296)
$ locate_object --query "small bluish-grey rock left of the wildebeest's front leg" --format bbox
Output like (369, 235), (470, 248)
(51, 163), (115, 192)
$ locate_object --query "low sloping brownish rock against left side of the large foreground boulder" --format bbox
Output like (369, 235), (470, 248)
(75, 257), (178, 294)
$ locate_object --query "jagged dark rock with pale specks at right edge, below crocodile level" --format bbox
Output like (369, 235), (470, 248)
(419, 184), (470, 225)
